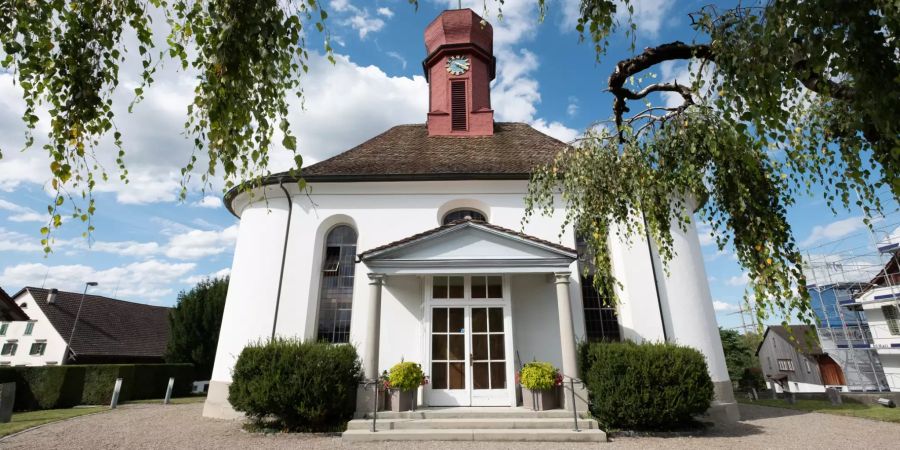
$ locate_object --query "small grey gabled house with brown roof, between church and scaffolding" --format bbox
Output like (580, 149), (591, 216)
(756, 325), (847, 392)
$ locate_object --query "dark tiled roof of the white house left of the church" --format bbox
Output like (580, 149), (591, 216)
(25, 287), (170, 361)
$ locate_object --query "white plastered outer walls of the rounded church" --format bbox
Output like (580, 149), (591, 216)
(213, 180), (727, 390)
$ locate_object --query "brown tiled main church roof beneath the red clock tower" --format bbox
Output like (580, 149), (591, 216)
(301, 122), (566, 181)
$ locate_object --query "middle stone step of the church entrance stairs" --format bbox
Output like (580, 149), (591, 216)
(347, 414), (599, 431)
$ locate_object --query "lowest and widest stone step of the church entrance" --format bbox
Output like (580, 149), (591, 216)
(342, 428), (606, 442)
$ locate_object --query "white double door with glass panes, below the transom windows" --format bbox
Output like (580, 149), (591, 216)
(427, 304), (515, 406)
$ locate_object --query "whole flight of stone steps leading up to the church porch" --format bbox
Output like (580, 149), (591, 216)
(343, 407), (606, 442)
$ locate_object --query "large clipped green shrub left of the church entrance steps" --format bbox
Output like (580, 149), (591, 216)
(228, 339), (362, 431)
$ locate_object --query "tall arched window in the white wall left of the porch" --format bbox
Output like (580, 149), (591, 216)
(318, 225), (356, 343)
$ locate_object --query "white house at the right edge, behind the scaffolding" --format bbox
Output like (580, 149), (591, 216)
(856, 248), (900, 392)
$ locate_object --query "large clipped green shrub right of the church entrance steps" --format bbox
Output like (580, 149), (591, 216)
(580, 342), (713, 430)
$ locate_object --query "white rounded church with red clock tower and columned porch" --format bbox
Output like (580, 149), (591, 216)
(204, 9), (737, 420)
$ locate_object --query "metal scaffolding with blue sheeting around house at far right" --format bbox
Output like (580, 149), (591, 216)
(803, 212), (900, 392)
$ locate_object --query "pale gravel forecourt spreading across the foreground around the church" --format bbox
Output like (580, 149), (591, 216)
(0, 403), (900, 450)
